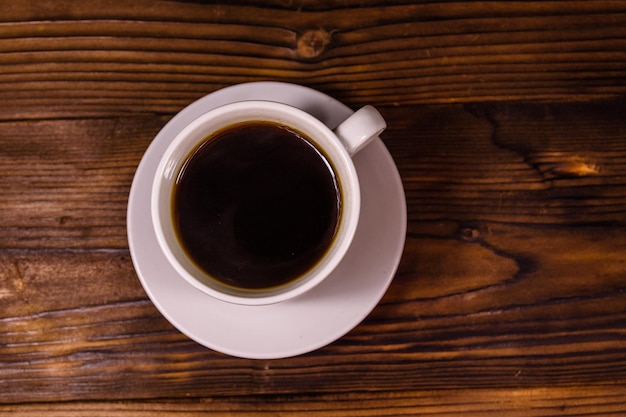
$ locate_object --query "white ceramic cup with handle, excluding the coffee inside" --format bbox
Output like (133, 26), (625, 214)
(151, 100), (386, 305)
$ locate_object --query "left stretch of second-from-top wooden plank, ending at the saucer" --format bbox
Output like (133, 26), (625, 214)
(0, 117), (166, 250)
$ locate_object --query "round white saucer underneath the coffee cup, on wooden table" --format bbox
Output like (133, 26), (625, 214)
(128, 82), (406, 359)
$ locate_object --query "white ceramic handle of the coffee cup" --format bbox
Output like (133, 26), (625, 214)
(334, 105), (387, 156)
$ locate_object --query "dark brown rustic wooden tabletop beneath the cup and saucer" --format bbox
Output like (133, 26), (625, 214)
(0, 0), (626, 417)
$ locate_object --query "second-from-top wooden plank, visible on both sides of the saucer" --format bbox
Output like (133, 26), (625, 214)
(0, 101), (626, 249)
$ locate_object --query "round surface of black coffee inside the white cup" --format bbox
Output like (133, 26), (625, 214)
(173, 122), (341, 290)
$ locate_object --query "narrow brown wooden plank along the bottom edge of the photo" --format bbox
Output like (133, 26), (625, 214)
(0, 386), (626, 417)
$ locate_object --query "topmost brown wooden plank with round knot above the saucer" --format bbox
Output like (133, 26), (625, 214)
(0, 0), (626, 118)
